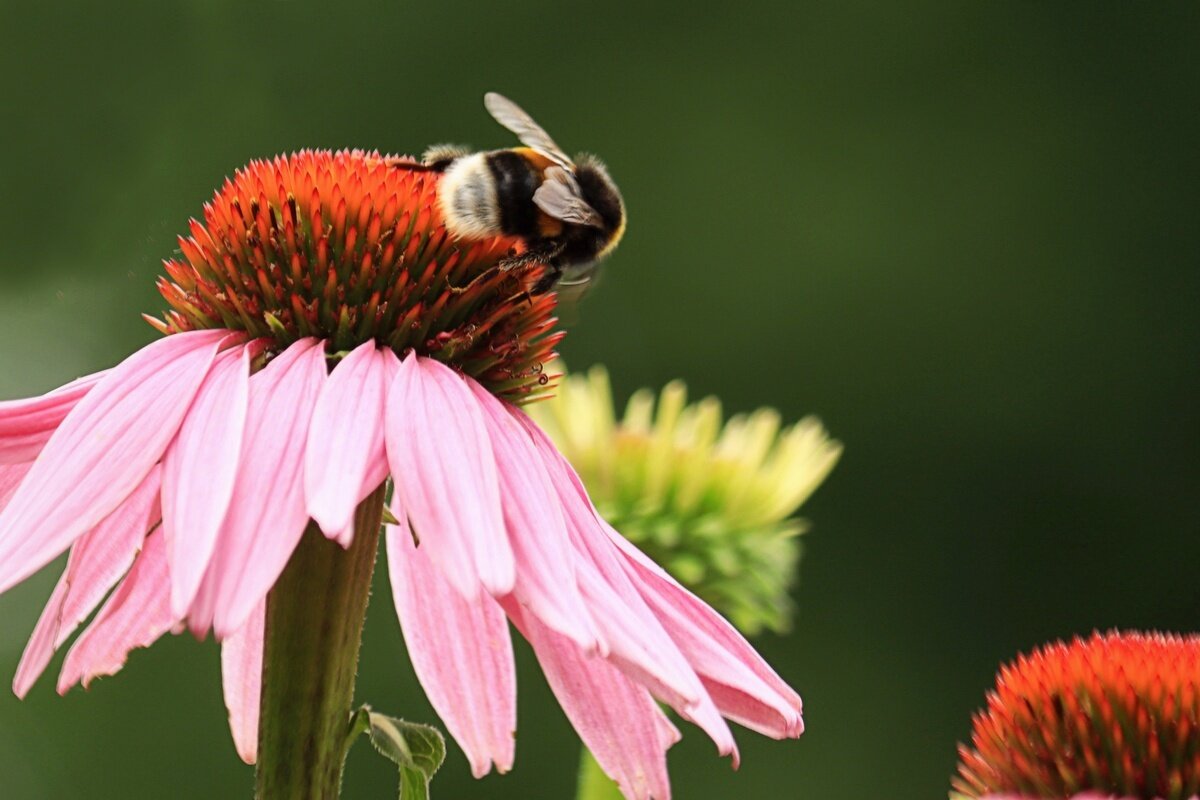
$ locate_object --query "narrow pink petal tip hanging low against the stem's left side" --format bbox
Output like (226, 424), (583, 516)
(221, 600), (266, 764)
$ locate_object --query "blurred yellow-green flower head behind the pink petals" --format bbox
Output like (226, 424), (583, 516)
(530, 366), (841, 633)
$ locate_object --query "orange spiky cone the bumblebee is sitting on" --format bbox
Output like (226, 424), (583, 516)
(148, 150), (562, 402)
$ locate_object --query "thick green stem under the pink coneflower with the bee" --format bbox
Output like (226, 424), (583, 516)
(256, 486), (385, 800)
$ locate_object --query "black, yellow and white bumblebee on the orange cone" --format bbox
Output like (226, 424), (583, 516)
(396, 92), (625, 294)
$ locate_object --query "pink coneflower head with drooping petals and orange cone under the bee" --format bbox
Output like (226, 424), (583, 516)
(0, 152), (803, 799)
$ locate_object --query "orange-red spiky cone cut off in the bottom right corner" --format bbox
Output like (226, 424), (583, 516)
(952, 632), (1200, 800)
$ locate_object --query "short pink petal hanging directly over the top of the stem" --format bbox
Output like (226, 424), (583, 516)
(305, 342), (396, 547)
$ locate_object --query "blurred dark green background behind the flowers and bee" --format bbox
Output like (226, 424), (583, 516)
(0, 0), (1200, 800)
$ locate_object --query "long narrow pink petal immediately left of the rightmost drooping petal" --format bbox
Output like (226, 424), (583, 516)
(511, 409), (740, 769)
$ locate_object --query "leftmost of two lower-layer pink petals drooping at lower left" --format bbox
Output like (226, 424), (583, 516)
(12, 467), (161, 698)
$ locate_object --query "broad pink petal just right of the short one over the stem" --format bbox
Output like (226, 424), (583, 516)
(385, 355), (516, 599)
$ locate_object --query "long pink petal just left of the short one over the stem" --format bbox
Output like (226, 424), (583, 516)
(205, 338), (325, 639)
